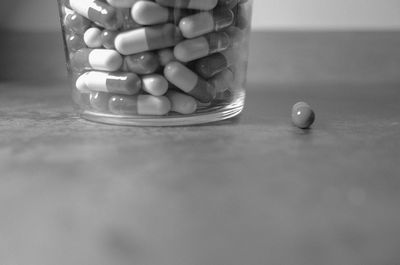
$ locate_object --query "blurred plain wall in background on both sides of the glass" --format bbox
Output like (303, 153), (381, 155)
(0, 0), (400, 31)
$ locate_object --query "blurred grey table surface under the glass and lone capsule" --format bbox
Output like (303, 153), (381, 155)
(0, 33), (400, 265)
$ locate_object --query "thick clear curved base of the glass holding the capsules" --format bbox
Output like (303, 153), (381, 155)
(80, 97), (244, 127)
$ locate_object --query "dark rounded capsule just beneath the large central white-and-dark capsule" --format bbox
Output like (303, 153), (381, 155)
(124, 52), (160, 75)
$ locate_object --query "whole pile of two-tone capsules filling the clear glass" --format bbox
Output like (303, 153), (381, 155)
(61, 0), (249, 115)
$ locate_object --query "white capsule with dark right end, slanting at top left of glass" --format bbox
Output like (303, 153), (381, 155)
(66, 0), (122, 30)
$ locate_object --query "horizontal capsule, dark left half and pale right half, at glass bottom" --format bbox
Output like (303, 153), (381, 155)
(108, 95), (171, 116)
